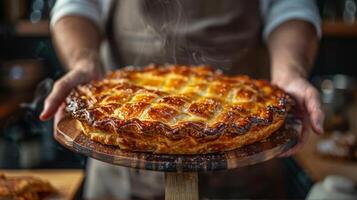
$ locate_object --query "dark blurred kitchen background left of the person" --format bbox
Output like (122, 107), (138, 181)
(0, 0), (82, 172)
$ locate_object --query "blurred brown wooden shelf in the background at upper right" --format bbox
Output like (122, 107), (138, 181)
(322, 21), (357, 37)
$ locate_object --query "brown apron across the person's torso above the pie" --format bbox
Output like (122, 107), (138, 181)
(108, 0), (261, 76)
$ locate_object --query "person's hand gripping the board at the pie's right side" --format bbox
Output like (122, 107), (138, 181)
(272, 73), (324, 157)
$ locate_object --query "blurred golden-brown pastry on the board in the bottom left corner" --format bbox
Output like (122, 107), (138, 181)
(0, 173), (55, 200)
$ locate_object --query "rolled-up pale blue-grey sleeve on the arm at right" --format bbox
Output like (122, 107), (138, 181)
(260, 0), (321, 40)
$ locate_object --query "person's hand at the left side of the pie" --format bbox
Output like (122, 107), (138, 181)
(40, 59), (104, 121)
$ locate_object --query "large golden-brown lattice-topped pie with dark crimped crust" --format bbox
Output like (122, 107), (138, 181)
(66, 64), (293, 154)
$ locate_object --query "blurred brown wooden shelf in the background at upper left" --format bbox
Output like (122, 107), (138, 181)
(15, 20), (50, 36)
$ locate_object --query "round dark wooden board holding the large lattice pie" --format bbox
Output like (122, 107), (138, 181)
(54, 116), (302, 172)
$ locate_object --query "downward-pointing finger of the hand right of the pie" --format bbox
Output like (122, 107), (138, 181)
(305, 86), (324, 134)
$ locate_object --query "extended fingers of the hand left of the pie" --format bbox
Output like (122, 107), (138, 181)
(40, 70), (84, 121)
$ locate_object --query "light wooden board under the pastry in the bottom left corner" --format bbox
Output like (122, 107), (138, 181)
(1, 170), (84, 200)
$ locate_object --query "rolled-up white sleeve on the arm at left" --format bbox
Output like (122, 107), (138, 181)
(51, 0), (112, 31)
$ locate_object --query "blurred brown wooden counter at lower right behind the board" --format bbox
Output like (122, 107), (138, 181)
(294, 133), (357, 182)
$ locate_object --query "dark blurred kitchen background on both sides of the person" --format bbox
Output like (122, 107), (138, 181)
(0, 0), (357, 199)
